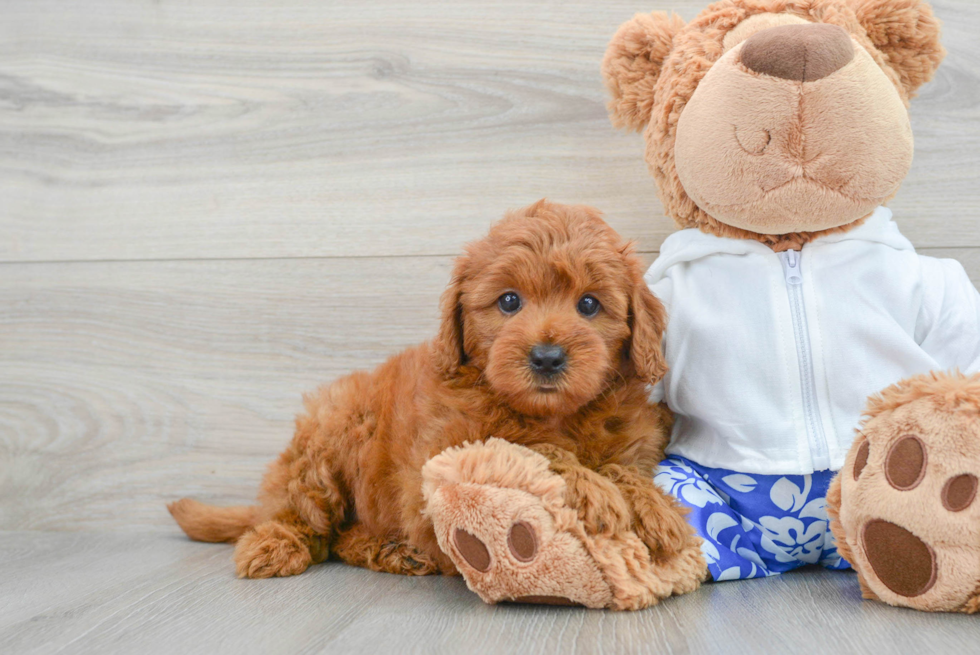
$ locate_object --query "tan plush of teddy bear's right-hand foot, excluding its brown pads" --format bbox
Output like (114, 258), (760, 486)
(827, 372), (980, 614)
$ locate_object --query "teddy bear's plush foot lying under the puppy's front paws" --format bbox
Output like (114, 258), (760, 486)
(422, 439), (707, 610)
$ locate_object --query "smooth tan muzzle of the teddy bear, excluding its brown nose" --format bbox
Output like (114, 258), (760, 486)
(674, 36), (912, 238)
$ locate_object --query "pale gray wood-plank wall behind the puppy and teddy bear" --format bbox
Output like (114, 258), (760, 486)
(0, 0), (980, 531)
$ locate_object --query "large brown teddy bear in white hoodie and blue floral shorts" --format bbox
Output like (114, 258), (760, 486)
(423, 0), (980, 613)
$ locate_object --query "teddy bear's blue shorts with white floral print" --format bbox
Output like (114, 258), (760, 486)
(654, 456), (851, 582)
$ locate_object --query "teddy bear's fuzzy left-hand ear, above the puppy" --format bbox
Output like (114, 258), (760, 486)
(602, 11), (684, 131)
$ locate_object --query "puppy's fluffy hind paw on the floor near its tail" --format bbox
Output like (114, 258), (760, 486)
(235, 521), (313, 578)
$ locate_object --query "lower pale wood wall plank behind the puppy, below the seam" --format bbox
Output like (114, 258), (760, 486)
(0, 249), (980, 531)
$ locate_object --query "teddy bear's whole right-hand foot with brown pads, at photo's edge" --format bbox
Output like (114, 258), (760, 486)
(828, 375), (980, 613)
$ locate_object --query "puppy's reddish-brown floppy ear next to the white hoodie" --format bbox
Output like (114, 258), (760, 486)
(627, 255), (667, 384)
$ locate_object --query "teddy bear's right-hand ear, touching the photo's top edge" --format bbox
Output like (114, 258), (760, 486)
(851, 0), (946, 98)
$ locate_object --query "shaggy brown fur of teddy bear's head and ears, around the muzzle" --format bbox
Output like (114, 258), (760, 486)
(603, 0), (945, 250)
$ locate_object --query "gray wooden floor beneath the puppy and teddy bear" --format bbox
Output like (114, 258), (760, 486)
(0, 533), (980, 655)
